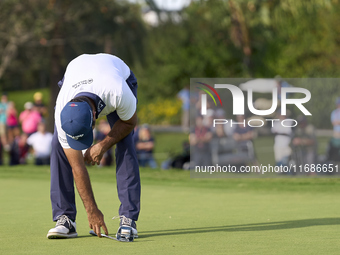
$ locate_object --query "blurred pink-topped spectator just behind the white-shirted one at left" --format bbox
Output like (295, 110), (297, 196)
(19, 102), (41, 135)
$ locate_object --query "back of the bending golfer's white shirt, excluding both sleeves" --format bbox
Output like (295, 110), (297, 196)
(56, 54), (131, 115)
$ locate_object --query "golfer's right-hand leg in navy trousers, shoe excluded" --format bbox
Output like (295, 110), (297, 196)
(107, 112), (141, 221)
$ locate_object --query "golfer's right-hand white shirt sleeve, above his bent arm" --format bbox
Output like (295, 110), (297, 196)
(116, 81), (137, 120)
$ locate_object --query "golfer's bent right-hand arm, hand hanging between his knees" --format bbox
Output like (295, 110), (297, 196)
(84, 112), (137, 165)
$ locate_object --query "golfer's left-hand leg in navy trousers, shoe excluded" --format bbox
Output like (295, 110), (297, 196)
(51, 128), (77, 221)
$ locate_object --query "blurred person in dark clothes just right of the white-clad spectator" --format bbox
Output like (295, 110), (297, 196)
(292, 116), (317, 165)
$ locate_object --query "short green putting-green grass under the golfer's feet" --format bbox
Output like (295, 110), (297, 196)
(0, 166), (340, 254)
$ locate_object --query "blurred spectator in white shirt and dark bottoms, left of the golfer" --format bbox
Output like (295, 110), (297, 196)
(27, 122), (53, 165)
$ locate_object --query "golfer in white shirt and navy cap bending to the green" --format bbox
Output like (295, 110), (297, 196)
(47, 54), (140, 241)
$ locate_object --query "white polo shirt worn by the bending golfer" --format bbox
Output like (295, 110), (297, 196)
(54, 54), (137, 148)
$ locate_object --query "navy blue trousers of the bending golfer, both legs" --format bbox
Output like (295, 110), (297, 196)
(50, 72), (141, 221)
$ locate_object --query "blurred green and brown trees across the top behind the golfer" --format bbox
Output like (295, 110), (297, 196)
(0, 0), (340, 125)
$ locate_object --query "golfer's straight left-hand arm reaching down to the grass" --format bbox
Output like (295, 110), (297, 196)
(64, 149), (108, 237)
